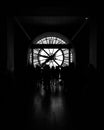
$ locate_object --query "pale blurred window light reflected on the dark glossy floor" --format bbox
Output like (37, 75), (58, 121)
(33, 80), (66, 129)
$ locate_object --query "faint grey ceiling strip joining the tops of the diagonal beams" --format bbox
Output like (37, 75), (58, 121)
(17, 16), (84, 25)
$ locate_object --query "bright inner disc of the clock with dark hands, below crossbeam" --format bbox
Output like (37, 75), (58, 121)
(38, 49), (64, 67)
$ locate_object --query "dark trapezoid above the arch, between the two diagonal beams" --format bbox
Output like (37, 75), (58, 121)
(14, 16), (88, 39)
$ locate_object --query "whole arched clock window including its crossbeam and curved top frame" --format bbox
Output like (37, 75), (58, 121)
(28, 33), (72, 68)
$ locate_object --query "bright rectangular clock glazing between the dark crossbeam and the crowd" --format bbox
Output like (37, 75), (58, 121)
(29, 48), (69, 68)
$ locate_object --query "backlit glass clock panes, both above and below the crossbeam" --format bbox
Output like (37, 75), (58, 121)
(29, 37), (69, 68)
